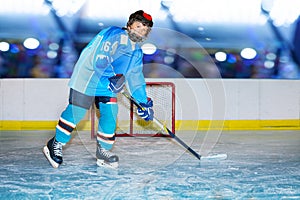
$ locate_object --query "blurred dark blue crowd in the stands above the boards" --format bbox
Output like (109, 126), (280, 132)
(0, 39), (299, 79)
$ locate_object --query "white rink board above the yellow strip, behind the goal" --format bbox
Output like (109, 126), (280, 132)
(0, 79), (300, 121)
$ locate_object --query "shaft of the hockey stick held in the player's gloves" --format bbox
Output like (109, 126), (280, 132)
(122, 91), (201, 160)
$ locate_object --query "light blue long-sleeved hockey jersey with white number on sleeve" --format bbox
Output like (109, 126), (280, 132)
(69, 26), (147, 103)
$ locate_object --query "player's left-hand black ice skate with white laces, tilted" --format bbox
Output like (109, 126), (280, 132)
(43, 137), (63, 168)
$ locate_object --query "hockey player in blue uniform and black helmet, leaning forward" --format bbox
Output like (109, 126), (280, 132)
(43, 10), (153, 168)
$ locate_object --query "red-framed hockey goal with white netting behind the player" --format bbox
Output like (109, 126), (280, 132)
(91, 82), (175, 137)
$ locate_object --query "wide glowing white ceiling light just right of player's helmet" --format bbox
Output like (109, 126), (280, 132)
(170, 0), (266, 24)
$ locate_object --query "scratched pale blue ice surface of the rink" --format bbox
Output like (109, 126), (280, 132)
(0, 130), (300, 200)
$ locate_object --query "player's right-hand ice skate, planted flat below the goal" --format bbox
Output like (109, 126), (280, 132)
(96, 143), (119, 169)
